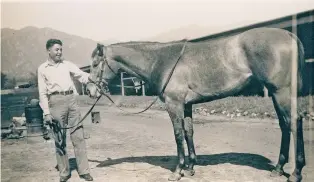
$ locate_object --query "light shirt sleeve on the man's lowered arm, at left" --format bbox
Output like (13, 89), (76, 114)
(37, 67), (50, 115)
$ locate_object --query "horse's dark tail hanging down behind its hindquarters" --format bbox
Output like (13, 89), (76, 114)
(289, 32), (305, 95)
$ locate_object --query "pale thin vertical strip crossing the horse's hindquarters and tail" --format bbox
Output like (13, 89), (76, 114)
(290, 15), (298, 169)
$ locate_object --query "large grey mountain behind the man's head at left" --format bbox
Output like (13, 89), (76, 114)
(1, 27), (97, 78)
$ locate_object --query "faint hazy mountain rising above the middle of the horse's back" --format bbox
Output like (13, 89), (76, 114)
(144, 25), (219, 42)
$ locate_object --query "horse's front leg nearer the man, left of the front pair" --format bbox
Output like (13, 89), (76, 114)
(166, 100), (185, 181)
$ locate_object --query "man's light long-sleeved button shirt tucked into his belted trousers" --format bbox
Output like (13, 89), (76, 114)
(38, 60), (89, 115)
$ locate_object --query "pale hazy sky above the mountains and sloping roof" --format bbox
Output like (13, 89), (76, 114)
(1, 0), (314, 41)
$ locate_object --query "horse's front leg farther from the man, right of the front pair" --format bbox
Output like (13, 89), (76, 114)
(184, 104), (196, 176)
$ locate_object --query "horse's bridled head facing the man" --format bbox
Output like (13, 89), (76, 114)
(86, 44), (118, 97)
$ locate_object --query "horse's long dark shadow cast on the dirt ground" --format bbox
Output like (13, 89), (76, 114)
(89, 153), (274, 171)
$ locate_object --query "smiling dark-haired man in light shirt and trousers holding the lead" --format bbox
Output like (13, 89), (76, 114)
(38, 39), (93, 182)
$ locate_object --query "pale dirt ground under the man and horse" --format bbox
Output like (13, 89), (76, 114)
(1, 106), (314, 182)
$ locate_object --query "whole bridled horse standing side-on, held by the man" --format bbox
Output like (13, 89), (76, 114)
(87, 28), (305, 182)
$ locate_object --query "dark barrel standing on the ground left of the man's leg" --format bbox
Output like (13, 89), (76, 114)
(25, 101), (44, 135)
